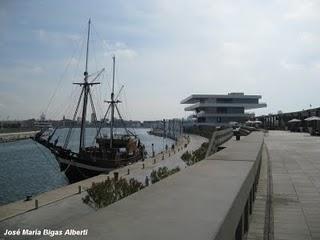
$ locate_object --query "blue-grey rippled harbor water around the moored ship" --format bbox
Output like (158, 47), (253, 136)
(0, 128), (174, 205)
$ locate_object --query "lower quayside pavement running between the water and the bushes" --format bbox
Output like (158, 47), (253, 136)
(0, 135), (207, 238)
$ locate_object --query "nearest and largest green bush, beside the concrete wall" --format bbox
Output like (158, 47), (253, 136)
(82, 178), (144, 208)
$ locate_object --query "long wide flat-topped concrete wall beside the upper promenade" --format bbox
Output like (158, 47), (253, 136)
(58, 132), (263, 240)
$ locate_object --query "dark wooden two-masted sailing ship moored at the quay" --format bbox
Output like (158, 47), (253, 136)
(34, 19), (145, 183)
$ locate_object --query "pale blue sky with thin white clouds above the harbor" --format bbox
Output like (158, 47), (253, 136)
(0, 0), (320, 120)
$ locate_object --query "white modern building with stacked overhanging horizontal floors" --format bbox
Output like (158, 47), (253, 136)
(181, 93), (267, 126)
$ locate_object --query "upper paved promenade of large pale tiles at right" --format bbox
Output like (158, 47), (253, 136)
(265, 131), (320, 240)
